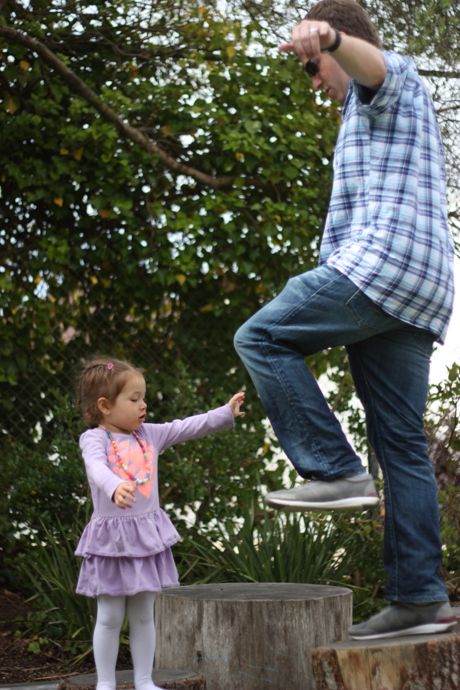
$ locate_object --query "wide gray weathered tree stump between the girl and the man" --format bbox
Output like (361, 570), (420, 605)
(155, 583), (352, 690)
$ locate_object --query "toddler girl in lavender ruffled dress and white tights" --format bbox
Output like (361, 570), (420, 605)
(75, 358), (244, 690)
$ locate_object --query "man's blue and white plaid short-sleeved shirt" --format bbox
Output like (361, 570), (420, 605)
(320, 52), (454, 342)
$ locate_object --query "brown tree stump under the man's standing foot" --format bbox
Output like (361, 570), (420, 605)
(312, 612), (460, 690)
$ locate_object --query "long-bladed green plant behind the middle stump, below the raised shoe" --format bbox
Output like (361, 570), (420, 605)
(175, 500), (385, 620)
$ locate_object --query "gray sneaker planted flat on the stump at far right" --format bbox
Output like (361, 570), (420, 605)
(349, 601), (457, 640)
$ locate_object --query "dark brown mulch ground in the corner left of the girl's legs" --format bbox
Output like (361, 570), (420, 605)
(0, 589), (94, 685)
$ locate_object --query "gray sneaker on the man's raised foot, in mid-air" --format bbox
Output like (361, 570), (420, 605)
(265, 473), (379, 511)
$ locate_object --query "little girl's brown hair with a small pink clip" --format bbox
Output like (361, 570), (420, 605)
(76, 357), (143, 427)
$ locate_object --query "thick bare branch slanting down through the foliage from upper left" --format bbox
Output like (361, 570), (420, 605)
(0, 24), (235, 189)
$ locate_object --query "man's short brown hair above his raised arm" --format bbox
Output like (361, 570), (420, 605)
(304, 0), (382, 48)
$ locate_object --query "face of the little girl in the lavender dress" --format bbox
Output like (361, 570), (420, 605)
(97, 372), (147, 433)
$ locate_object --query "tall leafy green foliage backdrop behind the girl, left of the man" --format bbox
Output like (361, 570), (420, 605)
(0, 0), (337, 576)
